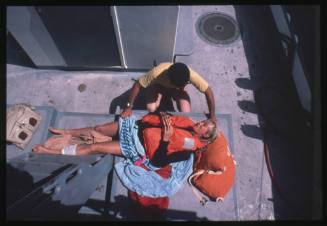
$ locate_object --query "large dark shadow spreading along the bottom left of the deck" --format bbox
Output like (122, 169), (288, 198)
(6, 164), (208, 221)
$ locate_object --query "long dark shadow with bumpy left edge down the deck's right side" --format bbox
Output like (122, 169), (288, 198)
(235, 5), (313, 220)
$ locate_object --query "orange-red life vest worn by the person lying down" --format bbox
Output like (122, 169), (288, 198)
(142, 114), (205, 160)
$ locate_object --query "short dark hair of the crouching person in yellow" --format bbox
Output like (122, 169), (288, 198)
(168, 63), (190, 87)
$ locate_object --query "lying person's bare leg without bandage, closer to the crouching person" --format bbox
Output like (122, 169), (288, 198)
(49, 122), (118, 137)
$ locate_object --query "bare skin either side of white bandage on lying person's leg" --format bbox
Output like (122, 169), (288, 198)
(33, 141), (122, 156)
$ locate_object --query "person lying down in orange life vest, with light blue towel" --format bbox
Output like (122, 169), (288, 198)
(33, 112), (217, 198)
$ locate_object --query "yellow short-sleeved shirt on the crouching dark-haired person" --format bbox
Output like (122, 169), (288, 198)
(138, 63), (209, 93)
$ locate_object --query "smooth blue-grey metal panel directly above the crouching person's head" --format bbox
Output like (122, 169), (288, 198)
(115, 6), (179, 69)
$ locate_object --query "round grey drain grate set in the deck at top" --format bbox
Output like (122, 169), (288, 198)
(196, 12), (239, 45)
